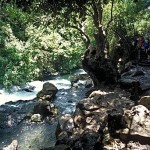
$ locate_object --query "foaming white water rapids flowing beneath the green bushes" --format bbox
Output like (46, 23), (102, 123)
(0, 69), (85, 105)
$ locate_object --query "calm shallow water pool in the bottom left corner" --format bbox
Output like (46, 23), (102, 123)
(0, 123), (56, 150)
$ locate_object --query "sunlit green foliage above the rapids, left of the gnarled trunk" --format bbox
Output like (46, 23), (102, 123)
(0, 5), (84, 87)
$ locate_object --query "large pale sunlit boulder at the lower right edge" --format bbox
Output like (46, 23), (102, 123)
(119, 105), (150, 144)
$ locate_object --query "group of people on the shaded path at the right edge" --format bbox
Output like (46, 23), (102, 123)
(134, 32), (150, 62)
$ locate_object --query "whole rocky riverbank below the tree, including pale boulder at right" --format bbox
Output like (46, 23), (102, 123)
(55, 86), (150, 150)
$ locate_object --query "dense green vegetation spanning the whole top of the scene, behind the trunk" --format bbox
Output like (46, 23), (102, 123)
(0, 0), (150, 86)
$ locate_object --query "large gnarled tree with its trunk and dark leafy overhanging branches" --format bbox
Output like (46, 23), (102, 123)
(41, 0), (116, 86)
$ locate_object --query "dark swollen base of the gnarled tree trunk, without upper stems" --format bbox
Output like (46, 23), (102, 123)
(82, 36), (117, 87)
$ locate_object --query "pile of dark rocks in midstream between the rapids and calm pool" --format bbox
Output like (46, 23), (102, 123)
(26, 82), (58, 122)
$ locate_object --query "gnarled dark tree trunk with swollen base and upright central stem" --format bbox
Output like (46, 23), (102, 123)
(82, 0), (117, 87)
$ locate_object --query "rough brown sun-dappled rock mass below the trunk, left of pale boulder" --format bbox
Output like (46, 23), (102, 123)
(56, 85), (137, 150)
